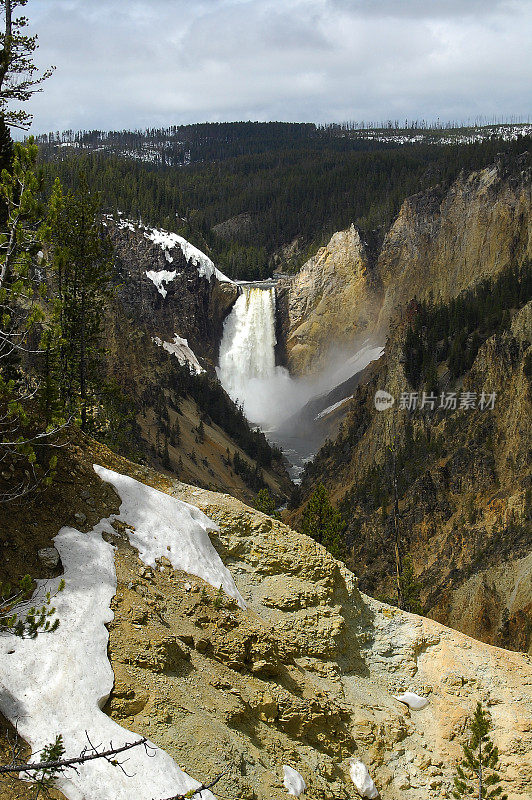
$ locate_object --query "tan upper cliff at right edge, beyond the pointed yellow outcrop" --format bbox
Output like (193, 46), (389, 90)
(377, 154), (532, 324)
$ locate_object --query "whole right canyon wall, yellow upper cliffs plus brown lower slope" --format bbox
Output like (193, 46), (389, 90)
(280, 152), (532, 650)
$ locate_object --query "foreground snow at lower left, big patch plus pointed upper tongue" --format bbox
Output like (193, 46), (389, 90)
(0, 466), (244, 800)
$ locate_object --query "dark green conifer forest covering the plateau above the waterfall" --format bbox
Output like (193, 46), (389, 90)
(36, 128), (532, 280)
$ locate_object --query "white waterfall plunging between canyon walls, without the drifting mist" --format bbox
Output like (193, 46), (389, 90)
(218, 285), (290, 427)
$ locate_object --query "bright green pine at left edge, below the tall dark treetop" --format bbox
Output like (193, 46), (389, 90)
(0, 141), (60, 500)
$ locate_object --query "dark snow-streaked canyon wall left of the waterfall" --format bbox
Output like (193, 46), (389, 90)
(88, 215), (291, 502)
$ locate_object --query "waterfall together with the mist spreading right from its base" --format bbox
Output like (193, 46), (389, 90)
(217, 284), (383, 477)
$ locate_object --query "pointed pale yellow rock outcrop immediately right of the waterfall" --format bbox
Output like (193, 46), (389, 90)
(277, 225), (380, 374)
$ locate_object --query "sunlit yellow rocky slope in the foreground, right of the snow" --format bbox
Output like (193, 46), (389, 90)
(104, 484), (532, 800)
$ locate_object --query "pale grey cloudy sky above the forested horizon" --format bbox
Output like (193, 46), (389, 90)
(26, 0), (532, 133)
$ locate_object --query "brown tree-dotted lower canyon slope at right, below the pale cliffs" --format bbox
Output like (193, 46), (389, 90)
(294, 302), (532, 653)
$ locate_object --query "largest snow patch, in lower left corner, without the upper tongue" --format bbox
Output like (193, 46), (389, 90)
(0, 520), (218, 800)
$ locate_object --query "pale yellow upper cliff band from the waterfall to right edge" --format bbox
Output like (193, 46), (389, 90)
(278, 159), (532, 374)
